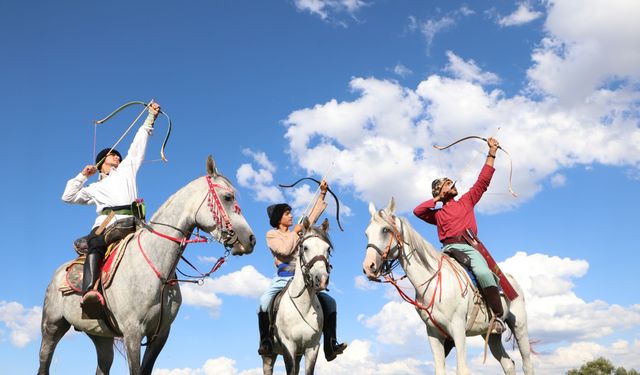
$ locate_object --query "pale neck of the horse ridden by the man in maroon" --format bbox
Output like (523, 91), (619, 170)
(400, 222), (441, 292)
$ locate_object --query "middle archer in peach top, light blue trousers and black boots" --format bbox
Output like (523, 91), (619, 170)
(258, 180), (347, 361)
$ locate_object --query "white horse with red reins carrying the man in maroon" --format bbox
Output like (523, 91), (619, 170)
(363, 198), (533, 375)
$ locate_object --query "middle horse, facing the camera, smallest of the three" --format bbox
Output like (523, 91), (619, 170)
(262, 218), (332, 375)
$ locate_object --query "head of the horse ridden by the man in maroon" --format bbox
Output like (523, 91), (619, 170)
(362, 197), (404, 281)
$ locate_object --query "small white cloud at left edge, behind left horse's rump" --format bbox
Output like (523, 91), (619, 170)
(0, 301), (42, 348)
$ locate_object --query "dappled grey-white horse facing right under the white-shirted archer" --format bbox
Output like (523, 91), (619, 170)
(38, 156), (256, 375)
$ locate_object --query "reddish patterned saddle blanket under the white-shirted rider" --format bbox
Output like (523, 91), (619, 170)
(58, 233), (135, 295)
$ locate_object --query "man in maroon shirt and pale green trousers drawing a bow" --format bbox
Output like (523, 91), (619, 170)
(413, 138), (504, 333)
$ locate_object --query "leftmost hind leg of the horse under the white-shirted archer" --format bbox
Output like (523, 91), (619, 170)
(38, 294), (71, 375)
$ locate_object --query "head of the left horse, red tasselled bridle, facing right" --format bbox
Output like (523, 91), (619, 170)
(196, 155), (256, 255)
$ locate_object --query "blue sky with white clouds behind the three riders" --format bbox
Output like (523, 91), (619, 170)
(0, 0), (640, 375)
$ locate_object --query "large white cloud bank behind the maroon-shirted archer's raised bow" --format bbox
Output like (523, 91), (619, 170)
(285, 65), (640, 212)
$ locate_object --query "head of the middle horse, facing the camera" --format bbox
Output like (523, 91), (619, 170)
(297, 218), (333, 292)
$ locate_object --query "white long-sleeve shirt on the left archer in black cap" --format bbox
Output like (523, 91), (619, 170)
(62, 114), (155, 228)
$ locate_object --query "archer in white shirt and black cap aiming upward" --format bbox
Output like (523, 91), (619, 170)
(62, 102), (160, 317)
